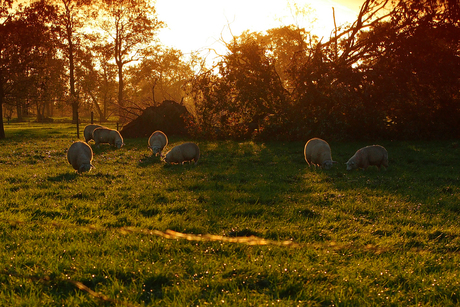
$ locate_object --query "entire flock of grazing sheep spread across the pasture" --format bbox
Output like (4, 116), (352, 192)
(67, 125), (388, 174)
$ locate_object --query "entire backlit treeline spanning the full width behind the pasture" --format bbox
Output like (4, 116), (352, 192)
(0, 0), (460, 140)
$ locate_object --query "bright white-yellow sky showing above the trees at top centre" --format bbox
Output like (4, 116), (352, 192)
(156, 0), (364, 62)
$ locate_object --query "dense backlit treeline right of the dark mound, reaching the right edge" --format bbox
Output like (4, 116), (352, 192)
(185, 0), (460, 140)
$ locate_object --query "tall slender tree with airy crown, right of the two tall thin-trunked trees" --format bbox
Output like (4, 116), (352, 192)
(96, 0), (164, 122)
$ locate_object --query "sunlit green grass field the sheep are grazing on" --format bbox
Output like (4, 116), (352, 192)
(0, 123), (460, 306)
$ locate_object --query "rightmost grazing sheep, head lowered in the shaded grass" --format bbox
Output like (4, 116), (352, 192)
(346, 145), (388, 171)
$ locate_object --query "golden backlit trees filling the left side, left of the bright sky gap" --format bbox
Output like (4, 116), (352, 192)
(0, 0), (198, 138)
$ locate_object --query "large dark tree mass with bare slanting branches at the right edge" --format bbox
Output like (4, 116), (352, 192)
(291, 0), (460, 138)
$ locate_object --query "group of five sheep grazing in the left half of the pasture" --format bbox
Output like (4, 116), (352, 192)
(67, 125), (200, 174)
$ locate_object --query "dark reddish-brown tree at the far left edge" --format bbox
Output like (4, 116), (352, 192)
(0, 1), (56, 138)
